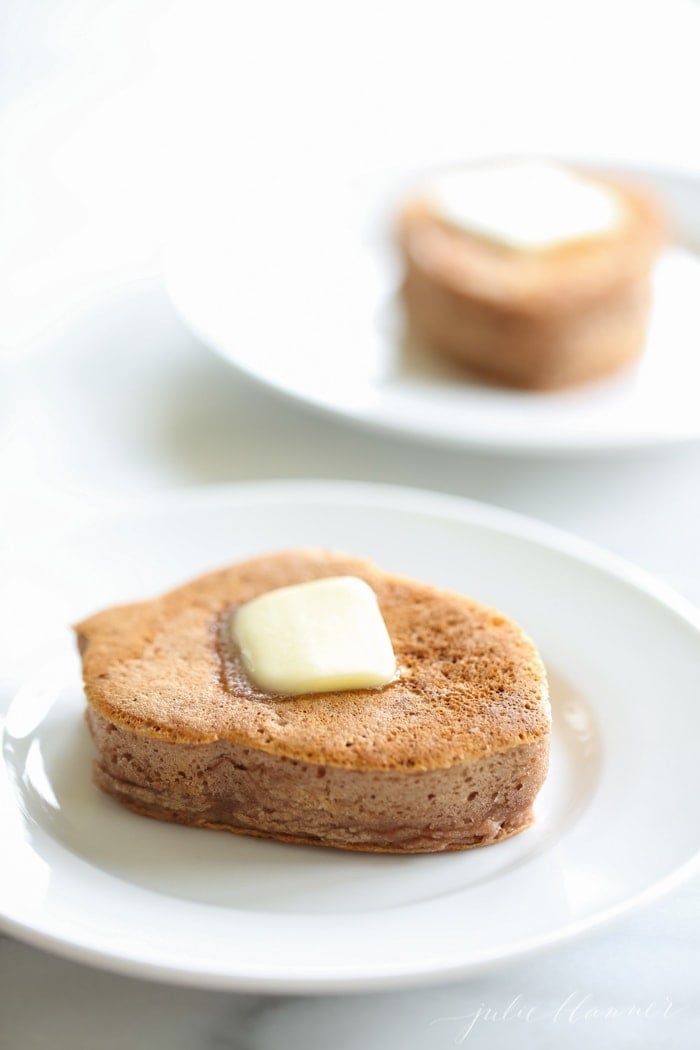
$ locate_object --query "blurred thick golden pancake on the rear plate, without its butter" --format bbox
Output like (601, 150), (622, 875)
(398, 163), (665, 390)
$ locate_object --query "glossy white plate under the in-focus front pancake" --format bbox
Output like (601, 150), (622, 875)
(0, 482), (700, 991)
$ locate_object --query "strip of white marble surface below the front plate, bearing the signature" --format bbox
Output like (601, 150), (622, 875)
(0, 894), (700, 1050)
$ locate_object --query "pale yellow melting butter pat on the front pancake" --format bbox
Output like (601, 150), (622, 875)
(231, 576), (396, 695)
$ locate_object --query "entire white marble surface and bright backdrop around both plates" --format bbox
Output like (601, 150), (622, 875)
(0, 0), (700, 1050)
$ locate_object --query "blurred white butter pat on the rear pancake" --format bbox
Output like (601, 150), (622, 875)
(427, 161), (623, 251)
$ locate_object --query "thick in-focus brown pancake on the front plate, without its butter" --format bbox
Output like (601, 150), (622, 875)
(76, 549), (550, 853)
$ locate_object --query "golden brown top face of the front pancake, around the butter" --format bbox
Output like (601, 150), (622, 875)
(76, 549), (549, 772)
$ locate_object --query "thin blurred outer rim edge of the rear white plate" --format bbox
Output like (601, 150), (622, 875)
(164, 159), (700, 459)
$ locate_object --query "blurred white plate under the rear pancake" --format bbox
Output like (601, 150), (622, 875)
(167, 166), (700, 455)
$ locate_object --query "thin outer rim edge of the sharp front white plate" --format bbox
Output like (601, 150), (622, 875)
(0, 479), (700, 994)
